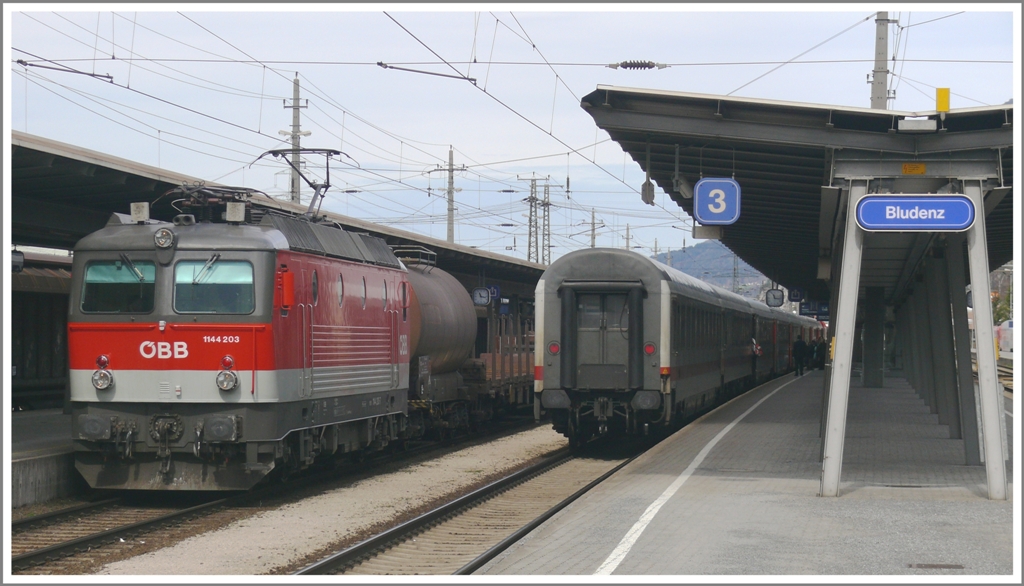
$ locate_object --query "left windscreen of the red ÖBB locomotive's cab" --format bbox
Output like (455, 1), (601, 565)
(82, 254), (157, 313)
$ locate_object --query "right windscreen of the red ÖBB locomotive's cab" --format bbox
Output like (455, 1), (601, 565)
(174, 254), (256, 313)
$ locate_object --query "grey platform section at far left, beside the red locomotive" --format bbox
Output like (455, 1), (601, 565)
(10, 409), (80, 508)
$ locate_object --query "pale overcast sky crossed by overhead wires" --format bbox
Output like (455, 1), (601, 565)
(3, 3), (1020, 259)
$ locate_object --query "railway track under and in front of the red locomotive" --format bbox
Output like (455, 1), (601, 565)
(11, 418), (534, 575)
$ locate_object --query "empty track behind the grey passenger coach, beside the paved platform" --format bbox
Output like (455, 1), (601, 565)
(295, 442), (635, 576)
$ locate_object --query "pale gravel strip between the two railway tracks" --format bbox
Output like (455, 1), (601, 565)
(97, 425), (567, 576)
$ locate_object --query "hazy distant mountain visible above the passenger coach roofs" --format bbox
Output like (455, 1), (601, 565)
(652, 240), (768, 299)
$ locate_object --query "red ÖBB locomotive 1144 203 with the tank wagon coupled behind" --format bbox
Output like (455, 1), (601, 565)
(68, 190), (530, 491)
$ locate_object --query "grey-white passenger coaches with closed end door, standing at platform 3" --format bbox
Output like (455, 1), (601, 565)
(535, 248), (821, 446)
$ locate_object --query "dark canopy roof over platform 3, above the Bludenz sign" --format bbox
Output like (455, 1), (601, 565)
(581, 85), (1014, 300)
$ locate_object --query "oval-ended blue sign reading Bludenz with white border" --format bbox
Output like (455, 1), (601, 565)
(857, 196), (975, 232)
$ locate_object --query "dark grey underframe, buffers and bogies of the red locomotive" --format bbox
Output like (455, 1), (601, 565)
(72, 391), (407, 491)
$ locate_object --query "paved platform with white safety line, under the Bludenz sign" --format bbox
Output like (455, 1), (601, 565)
(476, 371), (1020, 583)
